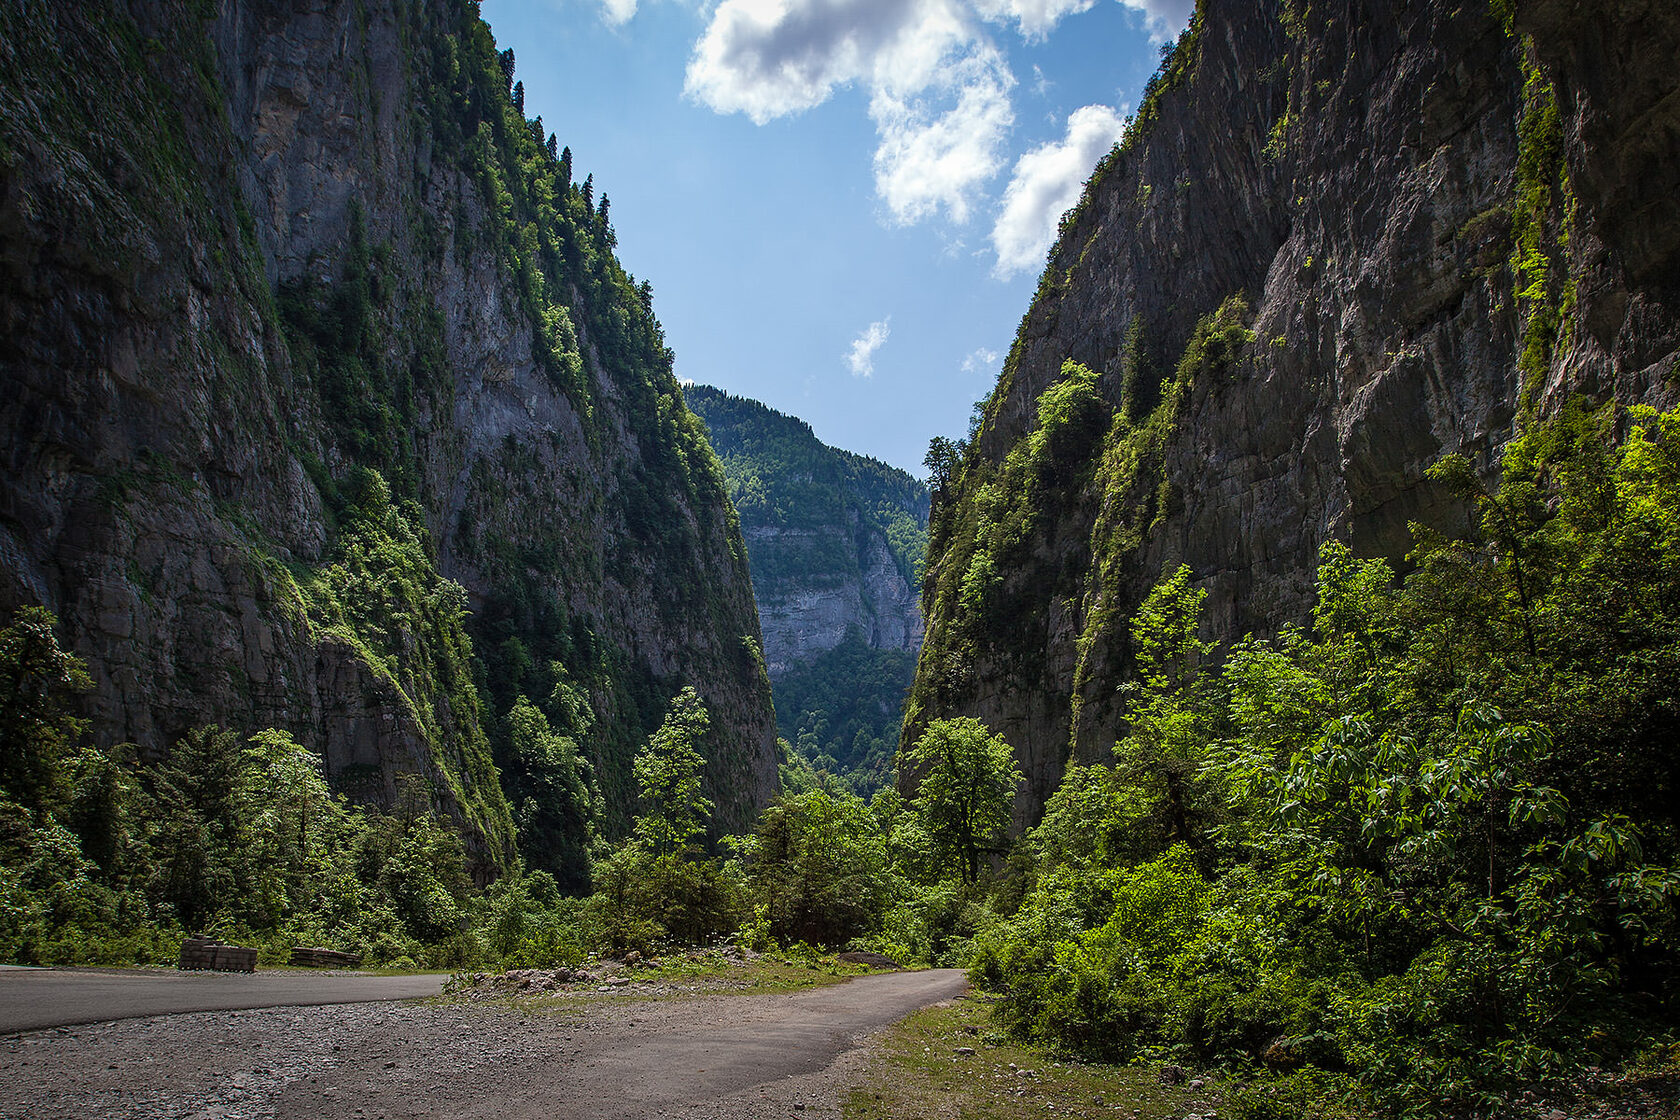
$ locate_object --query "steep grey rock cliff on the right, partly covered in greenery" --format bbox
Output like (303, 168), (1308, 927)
(904, 0), (1680, 821)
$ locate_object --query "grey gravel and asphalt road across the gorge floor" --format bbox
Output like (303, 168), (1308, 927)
(0, 971), (964, 1120)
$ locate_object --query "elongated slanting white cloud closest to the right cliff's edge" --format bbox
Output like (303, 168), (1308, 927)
(991, 106), (1126, 277)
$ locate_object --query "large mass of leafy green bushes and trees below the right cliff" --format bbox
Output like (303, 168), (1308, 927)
(976, 408), (1680, 1115)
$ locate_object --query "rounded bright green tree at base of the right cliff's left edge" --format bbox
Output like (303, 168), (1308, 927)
(909, 717), (1021, 883)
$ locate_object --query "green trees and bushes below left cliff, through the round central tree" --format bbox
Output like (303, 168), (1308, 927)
(0, 610), (1013, 967)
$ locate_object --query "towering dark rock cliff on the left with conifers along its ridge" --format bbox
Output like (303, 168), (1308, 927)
(0, 0), (776, 863)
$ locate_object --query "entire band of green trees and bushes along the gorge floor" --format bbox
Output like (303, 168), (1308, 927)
(0, 408), (1680, 1115)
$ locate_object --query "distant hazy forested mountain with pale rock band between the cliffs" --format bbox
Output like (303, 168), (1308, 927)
(685, 386), (927, 791)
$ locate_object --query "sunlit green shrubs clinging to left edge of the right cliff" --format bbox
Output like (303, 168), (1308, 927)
(906, 294), (1253, 737)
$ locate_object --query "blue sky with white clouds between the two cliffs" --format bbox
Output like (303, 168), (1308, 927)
(482, 0), (1193, 475)
